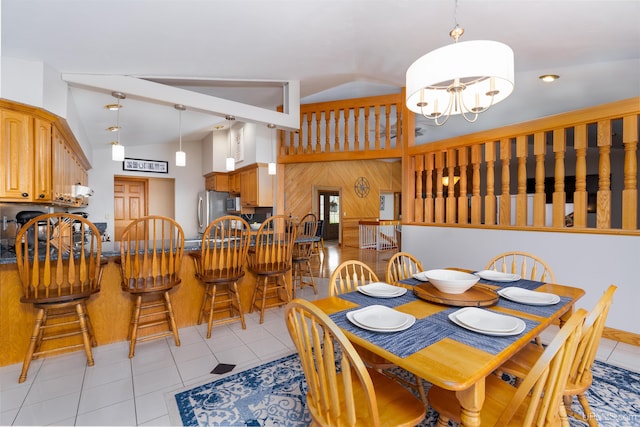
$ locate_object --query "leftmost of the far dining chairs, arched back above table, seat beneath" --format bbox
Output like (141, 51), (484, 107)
(329, 260), (427, 403)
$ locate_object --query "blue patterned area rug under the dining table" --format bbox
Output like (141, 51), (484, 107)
(168, 354), (640, 427)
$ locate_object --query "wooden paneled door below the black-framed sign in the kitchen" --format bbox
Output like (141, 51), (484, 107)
(113, 177), (148, 242)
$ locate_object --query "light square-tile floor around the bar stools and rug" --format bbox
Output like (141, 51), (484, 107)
(0, 279), (640, 426)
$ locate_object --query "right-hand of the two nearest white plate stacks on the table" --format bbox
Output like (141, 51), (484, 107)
(449, 307), (527, 336)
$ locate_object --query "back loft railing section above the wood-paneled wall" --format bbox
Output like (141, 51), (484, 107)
(278, 94), (403, 163)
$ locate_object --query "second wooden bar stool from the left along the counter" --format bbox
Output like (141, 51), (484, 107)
(119, 215), (184, 358)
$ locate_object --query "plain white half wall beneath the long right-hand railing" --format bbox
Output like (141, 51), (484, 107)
(402, 225), (640, 334)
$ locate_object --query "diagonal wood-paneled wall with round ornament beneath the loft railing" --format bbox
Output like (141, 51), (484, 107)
(284, 160), (402, 247)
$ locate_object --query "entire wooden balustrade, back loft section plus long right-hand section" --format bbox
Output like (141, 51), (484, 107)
(278, 94), (640, 235)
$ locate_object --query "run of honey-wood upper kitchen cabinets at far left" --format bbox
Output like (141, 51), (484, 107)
(0, 100), (89, 206)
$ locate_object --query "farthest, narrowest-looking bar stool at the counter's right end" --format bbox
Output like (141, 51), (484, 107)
(291, 213), (318, 298)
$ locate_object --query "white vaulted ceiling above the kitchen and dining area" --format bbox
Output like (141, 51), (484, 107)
(0, 0), (640, 152)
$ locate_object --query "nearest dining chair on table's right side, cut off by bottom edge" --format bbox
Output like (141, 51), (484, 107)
(429, 309), (587, 427)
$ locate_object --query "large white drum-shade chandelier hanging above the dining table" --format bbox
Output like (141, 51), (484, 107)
(406, 2), (514, 126)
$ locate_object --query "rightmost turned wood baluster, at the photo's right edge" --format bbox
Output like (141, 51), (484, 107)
(622, 115), (638, 230)
